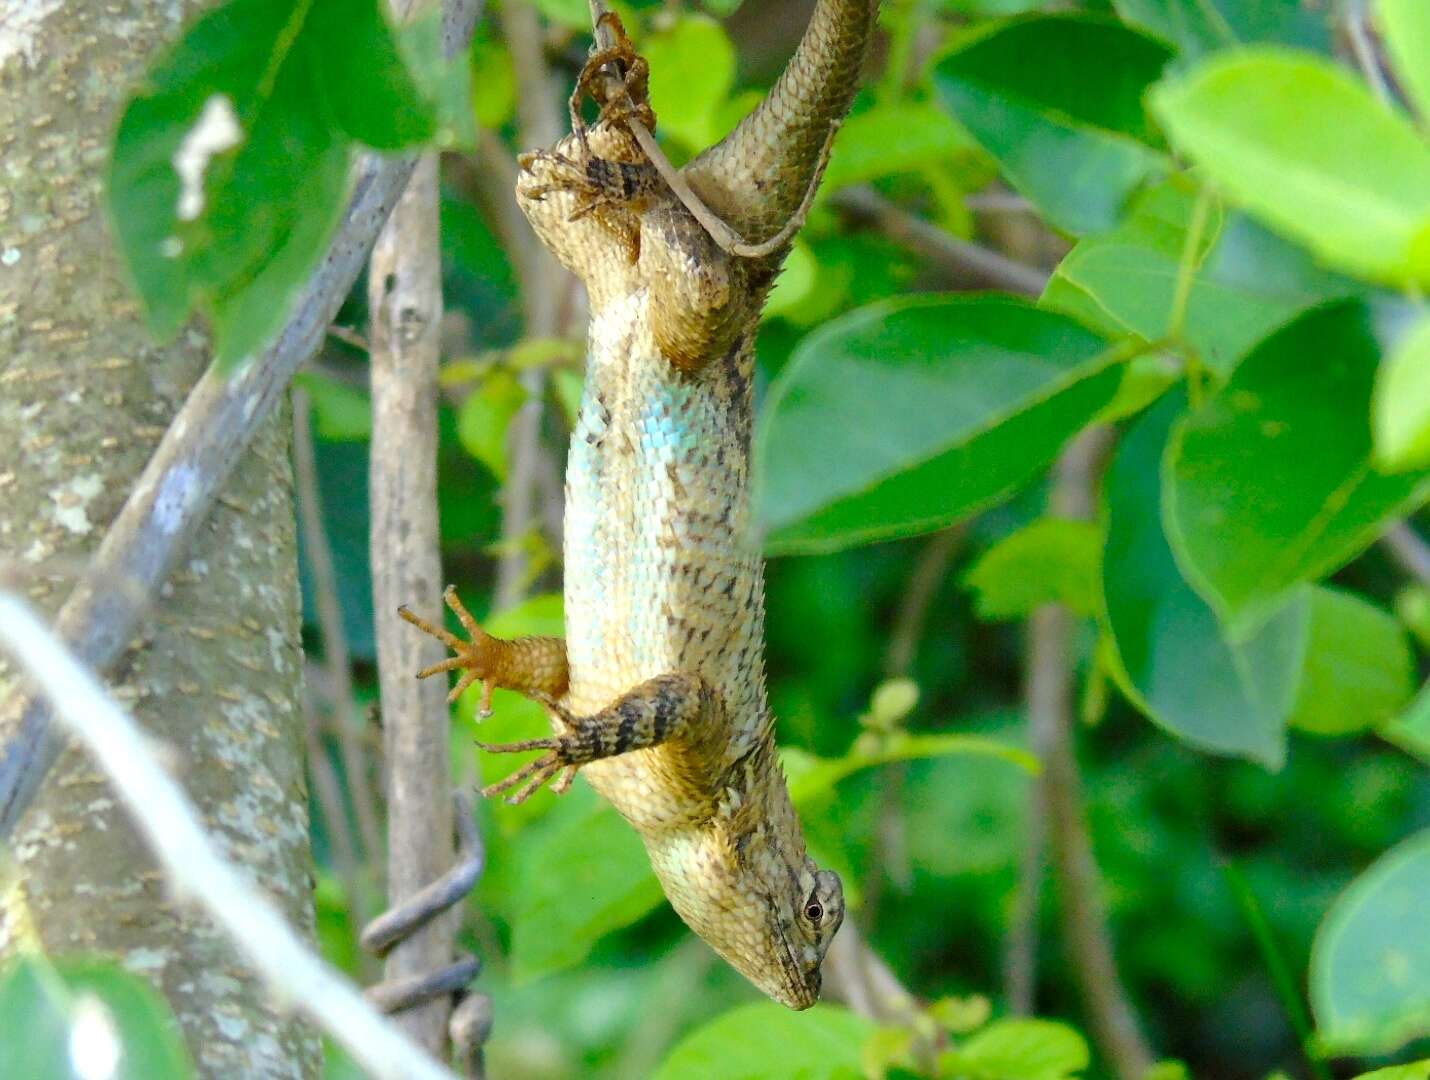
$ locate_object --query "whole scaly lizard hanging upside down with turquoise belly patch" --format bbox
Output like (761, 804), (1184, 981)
(406, 0), (877, 1008)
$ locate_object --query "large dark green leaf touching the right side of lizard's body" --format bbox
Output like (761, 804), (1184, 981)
(755, 296), (1120, 552)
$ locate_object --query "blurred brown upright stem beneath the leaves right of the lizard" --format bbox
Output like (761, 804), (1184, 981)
(1024, 428), (1153, 1080)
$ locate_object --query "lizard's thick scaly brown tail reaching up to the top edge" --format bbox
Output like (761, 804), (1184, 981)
(682, 0), (879, 242)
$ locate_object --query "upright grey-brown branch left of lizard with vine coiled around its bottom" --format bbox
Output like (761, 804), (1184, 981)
(368, 145), (456, 1053)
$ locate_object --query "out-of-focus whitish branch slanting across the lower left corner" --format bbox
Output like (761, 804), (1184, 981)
(0, 592), (452, 1080)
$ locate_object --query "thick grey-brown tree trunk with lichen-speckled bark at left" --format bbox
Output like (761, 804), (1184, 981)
(0, 0), (319, 1077)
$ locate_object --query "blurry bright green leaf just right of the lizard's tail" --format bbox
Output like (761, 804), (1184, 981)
(821, 102), (977, 193)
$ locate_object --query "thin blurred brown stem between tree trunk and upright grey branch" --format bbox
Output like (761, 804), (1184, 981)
(293, 389), (382, 869)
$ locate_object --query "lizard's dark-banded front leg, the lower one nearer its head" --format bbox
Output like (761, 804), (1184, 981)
(482, 672), (728, 804)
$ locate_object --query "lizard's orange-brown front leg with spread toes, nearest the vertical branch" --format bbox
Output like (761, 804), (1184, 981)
(398, 585), (571, 718)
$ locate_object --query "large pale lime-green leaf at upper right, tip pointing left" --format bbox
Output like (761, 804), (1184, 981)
(1153, 47), (1430, 286)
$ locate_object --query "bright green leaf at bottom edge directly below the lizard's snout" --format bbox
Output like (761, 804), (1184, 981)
(654, 1001), (875, 1080)
